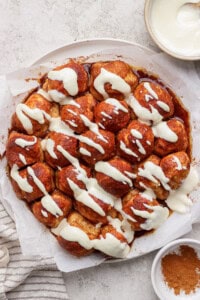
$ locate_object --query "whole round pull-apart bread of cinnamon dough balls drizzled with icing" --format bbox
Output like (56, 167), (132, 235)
(6, 60), (194, 258)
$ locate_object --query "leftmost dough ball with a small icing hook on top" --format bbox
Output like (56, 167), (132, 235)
(6, 131), (43, 169)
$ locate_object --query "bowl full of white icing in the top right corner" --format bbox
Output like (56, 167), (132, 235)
(144, 0), (200, 60)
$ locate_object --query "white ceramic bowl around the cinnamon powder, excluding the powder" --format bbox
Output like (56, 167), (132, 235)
(151, 239), (200, 300)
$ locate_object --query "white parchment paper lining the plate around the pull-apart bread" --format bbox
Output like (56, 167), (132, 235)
(0, 46), (200, 272)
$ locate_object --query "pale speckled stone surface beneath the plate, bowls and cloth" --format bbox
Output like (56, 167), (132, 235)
(0, 0), (200, 300)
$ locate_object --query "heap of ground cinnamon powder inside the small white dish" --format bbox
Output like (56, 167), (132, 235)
(161, 245), (200, 295)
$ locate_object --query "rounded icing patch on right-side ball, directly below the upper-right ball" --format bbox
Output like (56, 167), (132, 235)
(152, 121), (178, 143)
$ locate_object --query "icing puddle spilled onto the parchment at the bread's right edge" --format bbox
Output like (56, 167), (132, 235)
(166, 168), (199, 213)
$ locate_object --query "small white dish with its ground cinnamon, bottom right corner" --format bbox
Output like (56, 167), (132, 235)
(151, 239), (200, 300)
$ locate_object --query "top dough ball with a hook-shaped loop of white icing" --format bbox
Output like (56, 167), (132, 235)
(89, 60), (138, 101)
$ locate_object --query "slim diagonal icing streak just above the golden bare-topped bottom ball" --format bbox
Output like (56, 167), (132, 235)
(67, 178), (106, 216)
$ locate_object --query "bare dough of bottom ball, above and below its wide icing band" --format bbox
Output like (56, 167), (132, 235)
(57, 211), (100, 257)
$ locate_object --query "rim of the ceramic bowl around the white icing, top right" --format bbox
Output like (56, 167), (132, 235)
(144, 0), (200, 60)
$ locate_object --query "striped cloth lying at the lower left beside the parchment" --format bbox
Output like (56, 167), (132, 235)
(0, 202), (69, 300)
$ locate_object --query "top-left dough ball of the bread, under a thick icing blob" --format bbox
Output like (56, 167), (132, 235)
(44, 60), (88, 98)
